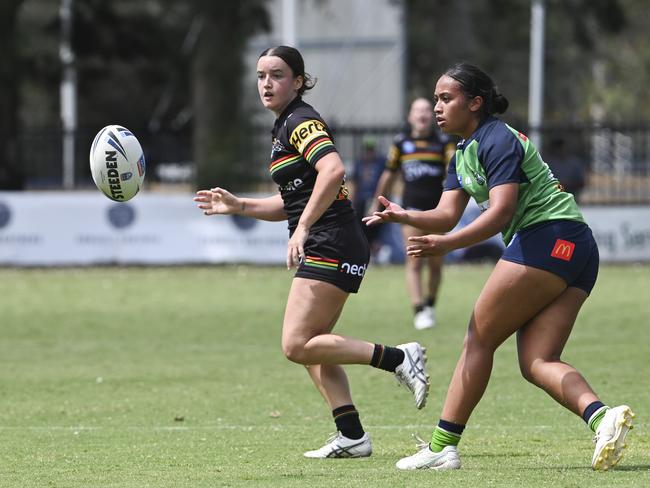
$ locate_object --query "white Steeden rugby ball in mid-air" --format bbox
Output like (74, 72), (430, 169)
(90, 125), (145, 202)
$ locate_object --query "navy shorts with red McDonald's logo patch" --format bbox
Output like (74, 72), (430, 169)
(501, 220), (600, 294)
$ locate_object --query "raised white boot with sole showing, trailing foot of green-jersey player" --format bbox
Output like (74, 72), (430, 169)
(591, 405), (634, 471)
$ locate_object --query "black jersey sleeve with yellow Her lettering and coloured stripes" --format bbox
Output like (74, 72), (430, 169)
(287, 114), (337, 166)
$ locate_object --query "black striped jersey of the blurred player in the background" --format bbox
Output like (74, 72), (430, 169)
(386, 129), (449, 208)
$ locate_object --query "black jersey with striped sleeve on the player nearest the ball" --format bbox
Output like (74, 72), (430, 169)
(269, 97), (354, 232)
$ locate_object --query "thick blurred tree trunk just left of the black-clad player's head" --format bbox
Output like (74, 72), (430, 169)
(191, 0), (269, 189)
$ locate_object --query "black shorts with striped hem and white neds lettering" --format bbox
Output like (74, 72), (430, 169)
(295, 217), (370, 293)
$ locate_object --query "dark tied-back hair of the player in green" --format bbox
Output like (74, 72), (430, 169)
(445, 63), (509, 116)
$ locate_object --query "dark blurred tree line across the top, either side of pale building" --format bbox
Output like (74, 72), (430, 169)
(0, 0), (650, 189)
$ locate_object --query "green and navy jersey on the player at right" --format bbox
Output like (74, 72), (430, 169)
(445, 117), (584, 245)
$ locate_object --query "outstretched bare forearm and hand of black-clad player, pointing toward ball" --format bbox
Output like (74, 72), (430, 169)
(194, 187), (287, 222)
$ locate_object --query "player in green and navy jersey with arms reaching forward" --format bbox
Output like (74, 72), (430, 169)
(364, 64), (634, 470)
